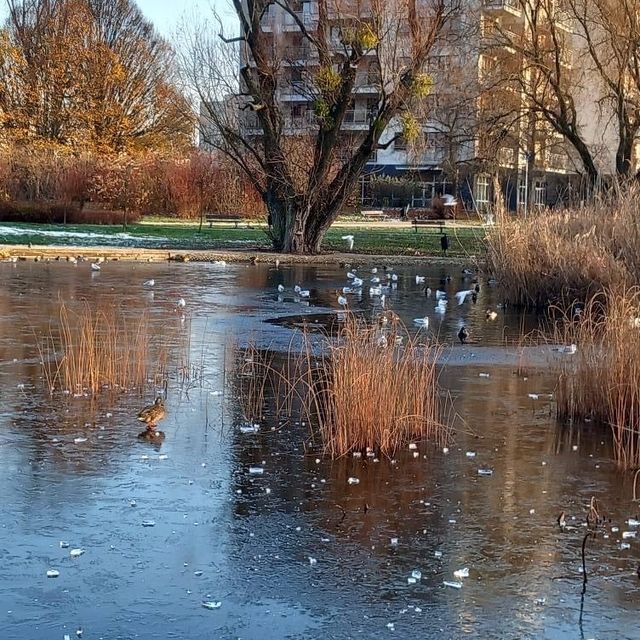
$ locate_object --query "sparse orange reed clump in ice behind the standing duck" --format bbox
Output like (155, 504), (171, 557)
(39, 302), (168, 395)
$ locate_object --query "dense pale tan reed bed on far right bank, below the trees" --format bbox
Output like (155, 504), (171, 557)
(487, 190), (640, 308)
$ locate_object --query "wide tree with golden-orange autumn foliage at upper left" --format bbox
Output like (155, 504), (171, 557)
(0, 0), (193, 152)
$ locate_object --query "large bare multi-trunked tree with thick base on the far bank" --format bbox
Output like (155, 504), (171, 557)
(184, 0), (457, 253)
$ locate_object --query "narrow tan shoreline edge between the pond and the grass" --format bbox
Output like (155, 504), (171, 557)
(0, 245), (482, 265)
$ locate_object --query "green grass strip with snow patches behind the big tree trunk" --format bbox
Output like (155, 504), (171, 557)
(0, 219), (484, 257)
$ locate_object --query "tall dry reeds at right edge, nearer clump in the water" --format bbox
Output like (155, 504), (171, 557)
(555, 288), (640, 469)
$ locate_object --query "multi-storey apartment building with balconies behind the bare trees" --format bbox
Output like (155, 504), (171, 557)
(230, 0), (600, 211)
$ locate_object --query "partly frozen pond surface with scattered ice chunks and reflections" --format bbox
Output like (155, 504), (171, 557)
(0, 262), (640, 640)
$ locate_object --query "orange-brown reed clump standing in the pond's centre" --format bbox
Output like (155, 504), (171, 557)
(235, 313), (450, 457)
